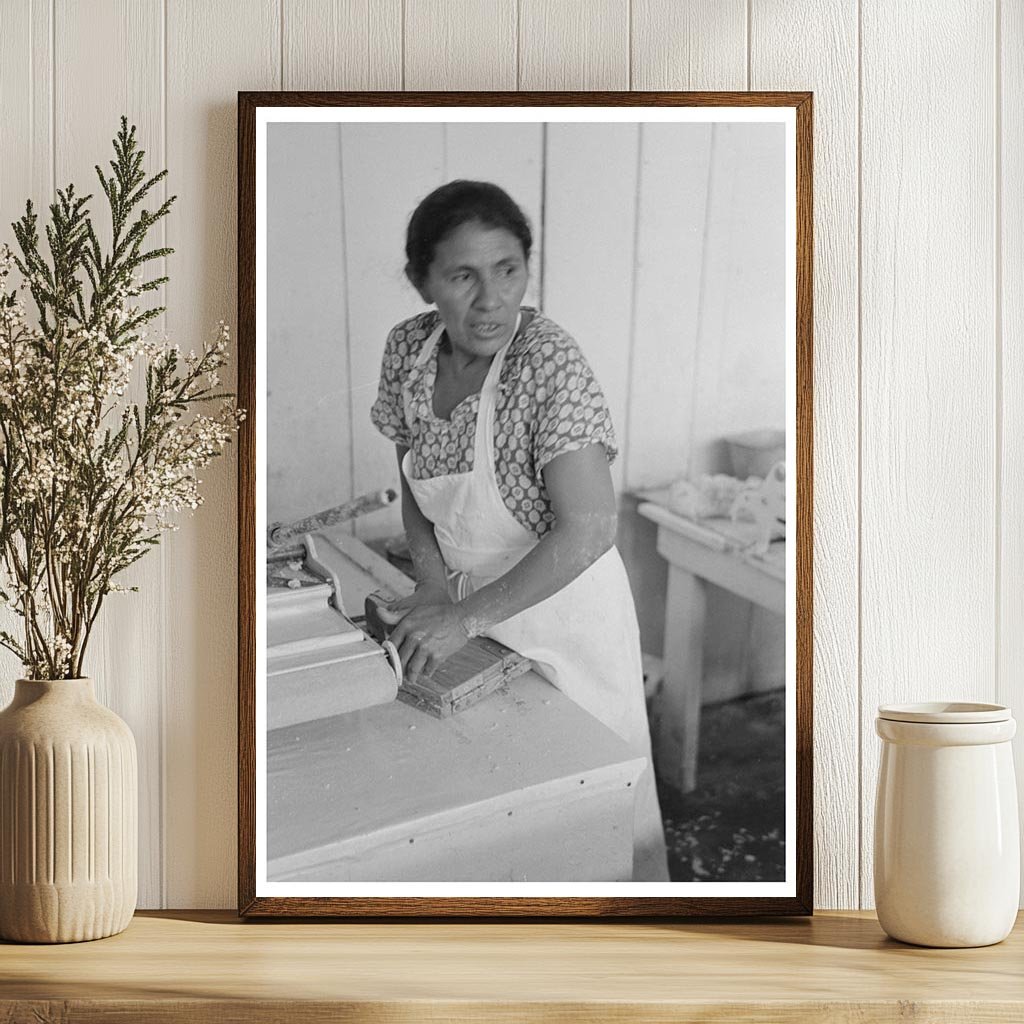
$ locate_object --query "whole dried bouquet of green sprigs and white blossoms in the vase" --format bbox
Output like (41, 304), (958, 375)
(0, 118), (245, 679)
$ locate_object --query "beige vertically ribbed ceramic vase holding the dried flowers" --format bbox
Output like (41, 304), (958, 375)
(0, 679), (138, 942)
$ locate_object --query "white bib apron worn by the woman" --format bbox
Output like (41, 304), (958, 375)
(401, 325), (669, 882)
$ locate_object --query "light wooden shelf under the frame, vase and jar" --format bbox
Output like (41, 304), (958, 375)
(0, 911), (1024, 1024)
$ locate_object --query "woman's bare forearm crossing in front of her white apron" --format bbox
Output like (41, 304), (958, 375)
(458, 515), (615, 636)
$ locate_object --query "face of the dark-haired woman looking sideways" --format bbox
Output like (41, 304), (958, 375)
(418, 220), (527, 356)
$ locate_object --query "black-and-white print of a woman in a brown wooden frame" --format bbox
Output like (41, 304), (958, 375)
(239, 92), (813, 916)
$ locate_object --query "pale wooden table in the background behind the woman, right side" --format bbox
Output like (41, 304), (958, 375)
(637, 490), (785, 793)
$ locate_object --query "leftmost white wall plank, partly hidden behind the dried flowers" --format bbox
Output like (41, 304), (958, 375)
(0, 0), (53, 708)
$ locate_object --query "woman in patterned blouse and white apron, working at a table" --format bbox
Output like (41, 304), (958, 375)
(372, 181), (669, 882)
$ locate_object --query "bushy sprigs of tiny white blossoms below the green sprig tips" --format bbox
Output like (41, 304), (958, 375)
(0, 256), (244, 676)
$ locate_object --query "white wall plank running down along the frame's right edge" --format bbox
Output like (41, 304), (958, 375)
(751, 0), (860, 907)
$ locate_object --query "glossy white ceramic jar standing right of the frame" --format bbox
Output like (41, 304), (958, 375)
(874, 703), (1020, 947)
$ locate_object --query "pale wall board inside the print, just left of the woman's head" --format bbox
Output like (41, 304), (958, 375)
(342, 124), (444, 538)
